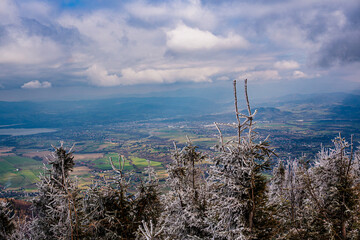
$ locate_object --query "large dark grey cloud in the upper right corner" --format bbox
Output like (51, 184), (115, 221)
(265, 0), (360, 69)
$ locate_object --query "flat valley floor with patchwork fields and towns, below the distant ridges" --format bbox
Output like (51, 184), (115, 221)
(0, 113), (360, 193)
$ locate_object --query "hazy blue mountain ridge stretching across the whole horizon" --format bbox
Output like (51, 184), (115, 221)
(0, 93), (360, 128)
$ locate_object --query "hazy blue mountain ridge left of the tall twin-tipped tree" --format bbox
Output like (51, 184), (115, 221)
(0, 97), (219, 127)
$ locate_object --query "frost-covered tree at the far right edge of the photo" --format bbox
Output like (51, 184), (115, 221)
(303, 136), (360, 239)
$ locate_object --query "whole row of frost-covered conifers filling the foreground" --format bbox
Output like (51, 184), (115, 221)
(0, 80), (360, 240)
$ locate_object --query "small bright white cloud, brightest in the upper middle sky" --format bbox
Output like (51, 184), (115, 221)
(166, 24), (249, 51)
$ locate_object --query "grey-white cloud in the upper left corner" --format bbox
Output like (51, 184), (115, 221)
(0, 0), (69, 66)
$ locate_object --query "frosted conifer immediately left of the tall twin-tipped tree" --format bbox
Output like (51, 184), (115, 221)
(162, 141), (209, 239)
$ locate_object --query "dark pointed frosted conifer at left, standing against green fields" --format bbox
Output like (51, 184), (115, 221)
(31, 143), (81, 239)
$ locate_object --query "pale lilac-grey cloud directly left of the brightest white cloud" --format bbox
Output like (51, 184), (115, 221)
(59, 10), (166, 67)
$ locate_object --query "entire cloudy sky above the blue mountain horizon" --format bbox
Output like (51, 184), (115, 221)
(0, 0), (360, 101)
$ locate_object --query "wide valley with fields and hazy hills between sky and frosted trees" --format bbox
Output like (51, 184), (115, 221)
(0, 92), (360, 197)
